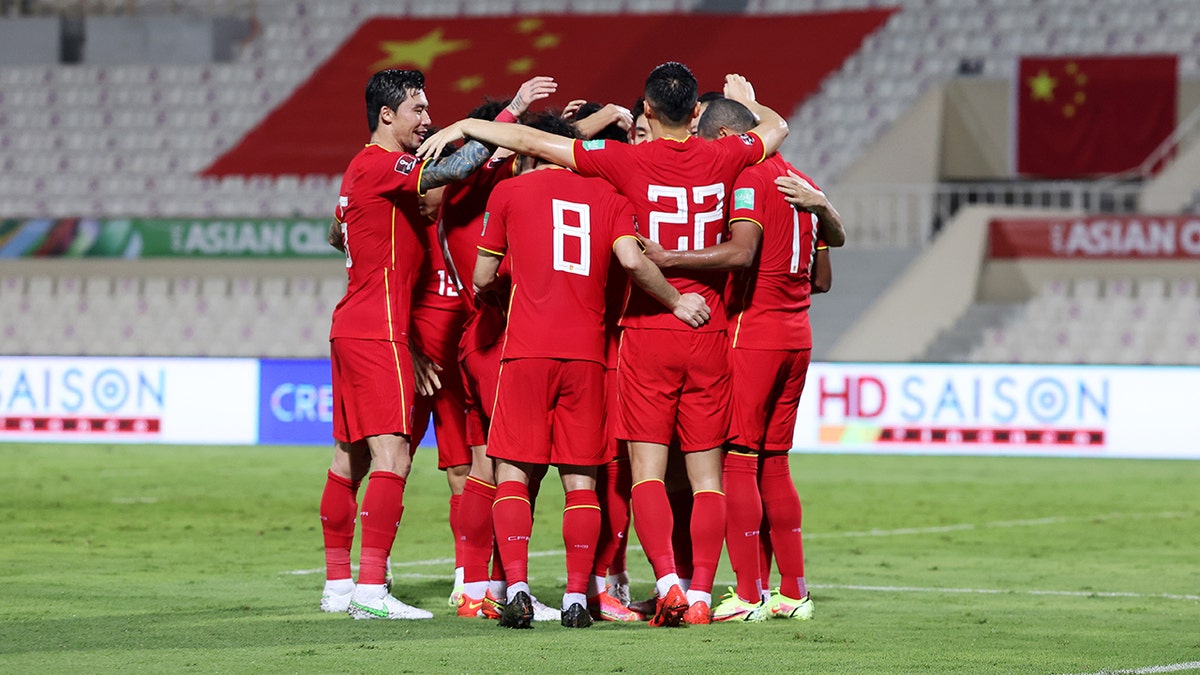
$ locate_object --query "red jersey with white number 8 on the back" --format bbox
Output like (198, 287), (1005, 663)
(479, 168), (636, 364)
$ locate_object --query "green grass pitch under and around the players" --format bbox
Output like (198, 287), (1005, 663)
(0, 444), (1200, 673)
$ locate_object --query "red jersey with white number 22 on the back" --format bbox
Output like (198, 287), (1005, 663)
(574, 133), (766, 331)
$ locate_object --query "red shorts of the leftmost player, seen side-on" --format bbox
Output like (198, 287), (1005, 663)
(329, 338), (415, 443)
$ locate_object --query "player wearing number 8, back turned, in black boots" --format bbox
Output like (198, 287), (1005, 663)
(474, 113), (709, 628)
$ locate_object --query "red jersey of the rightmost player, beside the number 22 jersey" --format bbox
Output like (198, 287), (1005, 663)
(730, 153), (820, 350)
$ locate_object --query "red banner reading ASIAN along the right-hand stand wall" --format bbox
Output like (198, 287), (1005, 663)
(988, 215), (1200, 259)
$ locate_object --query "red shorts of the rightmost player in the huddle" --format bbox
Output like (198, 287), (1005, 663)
(730, 348), (812, 452)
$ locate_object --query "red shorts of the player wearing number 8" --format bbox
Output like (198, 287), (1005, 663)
(487, 359), (607, 466)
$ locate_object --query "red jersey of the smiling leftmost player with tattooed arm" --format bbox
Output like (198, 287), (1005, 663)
(329, 143), (426, 345)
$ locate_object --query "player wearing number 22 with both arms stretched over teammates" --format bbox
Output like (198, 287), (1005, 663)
(420, 62), (787, 626)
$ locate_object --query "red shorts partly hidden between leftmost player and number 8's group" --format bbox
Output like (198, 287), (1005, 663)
(413, 306), (470, 470)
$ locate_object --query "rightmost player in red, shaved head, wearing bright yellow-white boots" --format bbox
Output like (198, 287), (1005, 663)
(646, 98), (845, 621)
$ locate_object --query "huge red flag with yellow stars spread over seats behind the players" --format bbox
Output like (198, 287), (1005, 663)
(203, 8), (895, 175)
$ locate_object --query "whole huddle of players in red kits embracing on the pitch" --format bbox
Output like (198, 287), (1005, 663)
(322, 62), (844, 628)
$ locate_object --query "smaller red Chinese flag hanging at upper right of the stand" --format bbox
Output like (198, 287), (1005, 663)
(1014, 55), (1178, 178)
